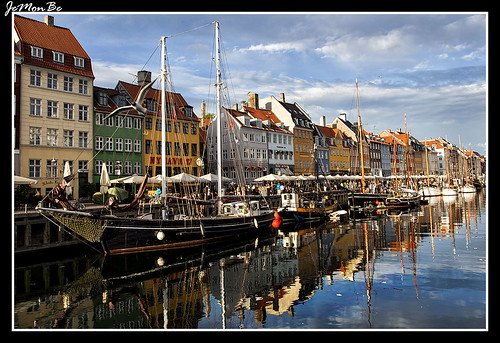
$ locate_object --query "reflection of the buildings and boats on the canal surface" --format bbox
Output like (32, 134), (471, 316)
(14, 194), (485, 329)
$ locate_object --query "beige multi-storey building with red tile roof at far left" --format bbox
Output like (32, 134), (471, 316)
(14, 15), (94, 199)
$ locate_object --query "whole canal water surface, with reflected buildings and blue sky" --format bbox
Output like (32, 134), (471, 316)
(13, 191), (487, 329)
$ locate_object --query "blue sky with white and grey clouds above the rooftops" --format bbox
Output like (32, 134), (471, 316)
(23, 12), (487, 154)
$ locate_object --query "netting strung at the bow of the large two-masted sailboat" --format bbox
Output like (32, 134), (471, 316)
(51, 212), (107, 242)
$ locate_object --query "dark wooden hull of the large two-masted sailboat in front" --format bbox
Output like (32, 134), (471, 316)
(38, 208), (274, 254)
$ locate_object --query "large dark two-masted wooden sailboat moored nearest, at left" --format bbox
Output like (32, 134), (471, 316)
(36, 21), (274, 254)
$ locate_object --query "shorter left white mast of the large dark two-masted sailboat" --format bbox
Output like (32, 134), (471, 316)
(161, 36), (167, 219)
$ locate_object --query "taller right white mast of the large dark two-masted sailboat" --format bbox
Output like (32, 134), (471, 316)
(215, 21), (222, 214)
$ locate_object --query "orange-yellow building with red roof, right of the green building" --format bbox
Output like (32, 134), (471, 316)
(116, 79), (201, 176)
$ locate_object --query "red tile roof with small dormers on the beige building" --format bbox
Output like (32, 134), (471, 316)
(14, 15), (94, 78)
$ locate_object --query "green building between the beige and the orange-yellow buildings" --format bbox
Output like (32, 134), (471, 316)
(93, 86), (144, 188)
